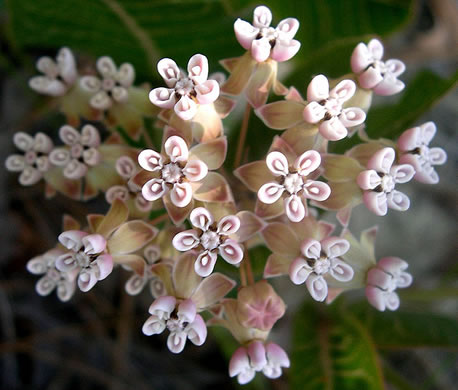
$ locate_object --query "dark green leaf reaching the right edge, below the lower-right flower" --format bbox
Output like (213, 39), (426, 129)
(349, 305), (458, 349)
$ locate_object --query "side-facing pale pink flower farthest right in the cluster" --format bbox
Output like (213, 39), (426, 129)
(397, 122), (447, 184)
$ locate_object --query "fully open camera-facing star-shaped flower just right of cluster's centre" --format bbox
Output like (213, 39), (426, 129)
(258, 150), (331, 222)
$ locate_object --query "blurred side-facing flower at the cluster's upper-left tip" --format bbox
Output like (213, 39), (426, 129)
(29, 47), (78, 96)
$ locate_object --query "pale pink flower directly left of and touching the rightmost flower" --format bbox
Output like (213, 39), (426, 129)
(356, 148), (415, 216)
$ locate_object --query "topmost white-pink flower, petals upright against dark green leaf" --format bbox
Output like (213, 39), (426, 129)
(234, 5), (301, 62)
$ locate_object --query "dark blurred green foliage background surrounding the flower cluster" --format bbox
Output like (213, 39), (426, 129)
(0, 0), (458, 390)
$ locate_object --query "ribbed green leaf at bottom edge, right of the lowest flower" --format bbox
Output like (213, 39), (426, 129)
(290, 304), (384, 390)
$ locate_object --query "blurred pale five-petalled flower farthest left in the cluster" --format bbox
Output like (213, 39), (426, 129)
(5, 131), (53, 186)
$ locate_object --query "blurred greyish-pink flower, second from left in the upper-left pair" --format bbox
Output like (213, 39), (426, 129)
(80, 56), (135, 110)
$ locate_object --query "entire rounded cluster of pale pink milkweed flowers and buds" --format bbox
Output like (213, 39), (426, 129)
(5, 6), (446, 384)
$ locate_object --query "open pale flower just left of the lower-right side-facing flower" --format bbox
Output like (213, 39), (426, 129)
(289, 237), (354, 302)
